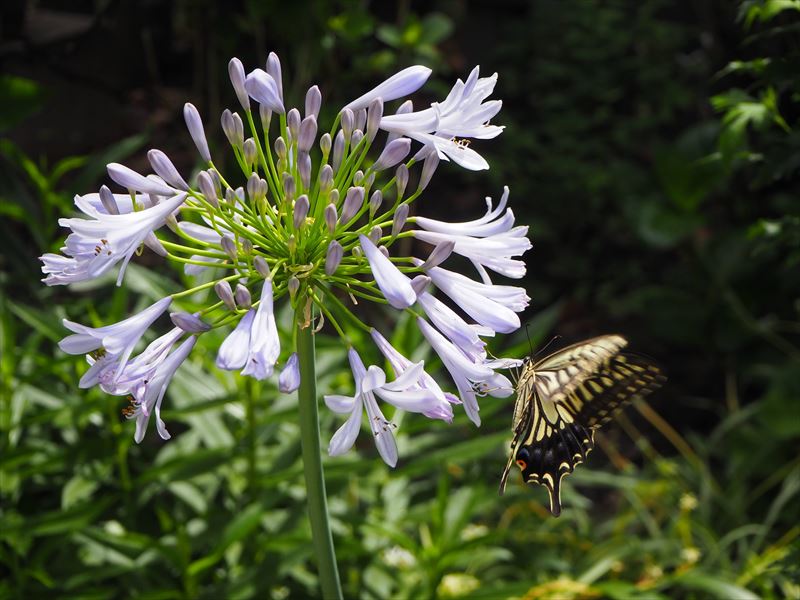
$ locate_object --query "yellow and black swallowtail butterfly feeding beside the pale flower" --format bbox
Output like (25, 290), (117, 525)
(500, 335), (666, 517)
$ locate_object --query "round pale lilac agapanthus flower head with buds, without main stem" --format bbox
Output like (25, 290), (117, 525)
(41, 53), (530, 466)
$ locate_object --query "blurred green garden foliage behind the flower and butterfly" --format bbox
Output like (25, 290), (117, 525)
(0, 0), (800, 600)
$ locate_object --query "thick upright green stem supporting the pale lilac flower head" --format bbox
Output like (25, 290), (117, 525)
(295, 318), (342, 600)
